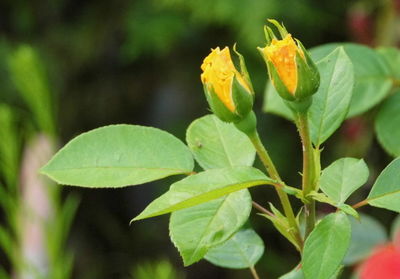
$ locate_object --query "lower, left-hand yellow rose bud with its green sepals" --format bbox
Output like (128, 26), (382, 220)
(201, 47), (254, 122)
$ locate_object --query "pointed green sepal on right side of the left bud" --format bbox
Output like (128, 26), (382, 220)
(232, 76), (254, 118)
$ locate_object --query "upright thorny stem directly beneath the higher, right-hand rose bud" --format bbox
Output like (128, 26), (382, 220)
(296, 112), (316, 238)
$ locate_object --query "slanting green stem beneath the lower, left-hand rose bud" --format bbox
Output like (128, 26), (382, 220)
(249, 131), (302, 249)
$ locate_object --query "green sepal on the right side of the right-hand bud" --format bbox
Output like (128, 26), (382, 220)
(294, 43), (320, 100)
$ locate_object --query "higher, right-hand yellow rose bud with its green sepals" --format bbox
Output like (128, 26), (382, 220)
(258, 20), (320, 104)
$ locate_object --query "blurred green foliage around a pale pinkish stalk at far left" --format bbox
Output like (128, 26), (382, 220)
(0, 45), (78, 279)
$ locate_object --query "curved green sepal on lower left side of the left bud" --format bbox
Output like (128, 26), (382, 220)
(203, 85), (241, 122)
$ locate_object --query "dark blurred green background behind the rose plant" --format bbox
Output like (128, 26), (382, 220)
(0, 0), (399, 279)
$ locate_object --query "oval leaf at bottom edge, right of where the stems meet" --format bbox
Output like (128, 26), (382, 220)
(302, 212), (351, 279)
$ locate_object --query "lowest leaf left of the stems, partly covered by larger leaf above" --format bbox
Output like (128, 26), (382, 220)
(205, 228), (264, 269)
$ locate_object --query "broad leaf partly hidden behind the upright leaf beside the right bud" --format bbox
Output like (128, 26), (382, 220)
(311, 43), (392, 118)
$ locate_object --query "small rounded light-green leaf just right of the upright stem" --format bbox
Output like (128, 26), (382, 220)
(320, 158), (369, 204)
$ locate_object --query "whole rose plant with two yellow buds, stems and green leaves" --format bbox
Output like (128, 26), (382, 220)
(41, 20), (400, 279)
